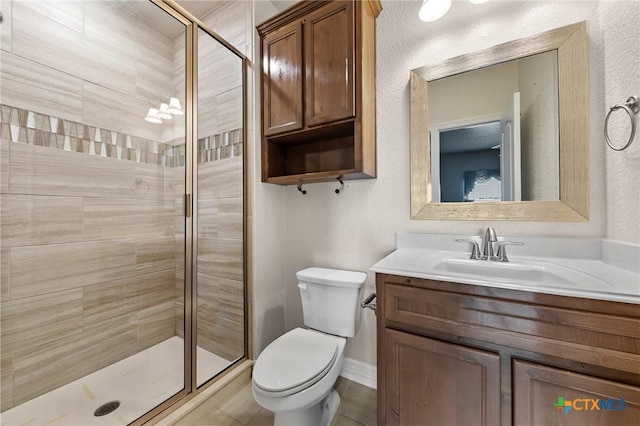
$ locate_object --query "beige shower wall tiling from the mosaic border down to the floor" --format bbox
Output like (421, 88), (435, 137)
(0, 105), (243, 409)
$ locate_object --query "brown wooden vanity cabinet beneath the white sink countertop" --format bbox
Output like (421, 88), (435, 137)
(376, 274), (640, 426)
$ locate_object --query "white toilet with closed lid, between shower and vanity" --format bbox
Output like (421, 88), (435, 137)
(252, 268), (367, 426)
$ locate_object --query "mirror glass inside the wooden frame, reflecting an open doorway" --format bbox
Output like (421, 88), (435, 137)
(428, 50), (560, 202)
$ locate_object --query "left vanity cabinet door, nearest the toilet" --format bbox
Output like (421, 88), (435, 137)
(383, 329), (500, 426)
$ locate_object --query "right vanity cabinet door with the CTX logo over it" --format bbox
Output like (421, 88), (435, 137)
(513, 361), (640, 426)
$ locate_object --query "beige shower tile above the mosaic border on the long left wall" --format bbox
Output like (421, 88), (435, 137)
(0, 0), (176, 141)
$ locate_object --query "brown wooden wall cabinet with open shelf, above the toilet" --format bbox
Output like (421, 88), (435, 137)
(258, 0), (382, 185)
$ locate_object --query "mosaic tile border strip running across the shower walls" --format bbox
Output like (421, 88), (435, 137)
(0, 105), (243, 167)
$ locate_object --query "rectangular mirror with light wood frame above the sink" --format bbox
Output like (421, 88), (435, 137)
(410, 22), (589, 222)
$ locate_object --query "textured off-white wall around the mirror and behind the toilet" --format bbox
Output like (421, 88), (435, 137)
(276, 0), (640, 372)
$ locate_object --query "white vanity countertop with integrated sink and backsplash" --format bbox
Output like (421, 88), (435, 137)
(372, 234), (640, 304)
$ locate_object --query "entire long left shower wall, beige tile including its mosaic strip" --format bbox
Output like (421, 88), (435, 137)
(0, 1), (176, 410)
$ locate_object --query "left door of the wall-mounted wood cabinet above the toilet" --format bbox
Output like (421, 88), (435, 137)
(262, 21), (303, 135)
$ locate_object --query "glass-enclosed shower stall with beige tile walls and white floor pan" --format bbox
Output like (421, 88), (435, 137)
(0, 0), (250, 425)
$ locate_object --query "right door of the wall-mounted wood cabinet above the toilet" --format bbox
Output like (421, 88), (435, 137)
(304, 1), (355, 127)
